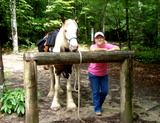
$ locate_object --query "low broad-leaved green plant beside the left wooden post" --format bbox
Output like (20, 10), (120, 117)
(0, 88), (25, 116)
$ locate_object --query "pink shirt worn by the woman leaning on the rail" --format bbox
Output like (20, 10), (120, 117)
(88, 43), (114, 76)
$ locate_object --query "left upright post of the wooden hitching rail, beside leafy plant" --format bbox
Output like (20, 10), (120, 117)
(24, 61), (39, 123)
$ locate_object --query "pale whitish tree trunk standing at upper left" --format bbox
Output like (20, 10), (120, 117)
(10, 0), (18, 53)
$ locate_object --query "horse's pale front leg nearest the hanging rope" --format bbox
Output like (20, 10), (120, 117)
(67, 74), (77, 110)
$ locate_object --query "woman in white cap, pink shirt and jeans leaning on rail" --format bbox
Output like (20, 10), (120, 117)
(88, 32), (119, 115)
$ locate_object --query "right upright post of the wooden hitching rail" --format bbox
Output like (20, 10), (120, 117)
(120, 58), (133, 123)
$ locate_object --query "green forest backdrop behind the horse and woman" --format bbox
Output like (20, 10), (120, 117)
(0, 0), (160, 62)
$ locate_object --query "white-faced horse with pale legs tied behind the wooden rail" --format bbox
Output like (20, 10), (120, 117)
(51, 19), (78, 110)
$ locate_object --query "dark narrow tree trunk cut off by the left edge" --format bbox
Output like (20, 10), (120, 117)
(0, 44), (4, 85)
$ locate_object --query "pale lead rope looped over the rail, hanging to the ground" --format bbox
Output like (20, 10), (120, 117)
(76, 50), (85, 123)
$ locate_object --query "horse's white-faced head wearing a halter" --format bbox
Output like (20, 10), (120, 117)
(63, 19), (78, 52)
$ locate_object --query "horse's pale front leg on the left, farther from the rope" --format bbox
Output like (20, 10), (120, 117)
(51, 74), (61, 111)
